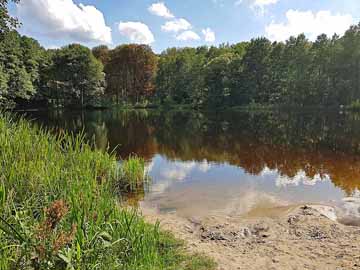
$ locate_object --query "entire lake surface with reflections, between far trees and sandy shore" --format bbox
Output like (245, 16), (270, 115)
(29, 110), (360, 221)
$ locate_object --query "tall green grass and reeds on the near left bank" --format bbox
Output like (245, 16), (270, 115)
(0, 114), (215, 270)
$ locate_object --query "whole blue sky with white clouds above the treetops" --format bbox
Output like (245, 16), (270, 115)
(7, 0), (360, 52)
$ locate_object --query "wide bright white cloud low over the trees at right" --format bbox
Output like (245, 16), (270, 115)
(265, 10), (354, 41)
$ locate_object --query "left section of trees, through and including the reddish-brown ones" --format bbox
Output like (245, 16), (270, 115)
(0, 31), (157, 107)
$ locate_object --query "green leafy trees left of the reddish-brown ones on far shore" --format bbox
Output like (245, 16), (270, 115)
(0, 31), (105, 106)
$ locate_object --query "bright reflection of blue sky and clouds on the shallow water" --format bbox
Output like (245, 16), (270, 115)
(146, 155), (344, 216)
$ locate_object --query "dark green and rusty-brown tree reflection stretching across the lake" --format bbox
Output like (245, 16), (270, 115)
(26, 108), (360, 193)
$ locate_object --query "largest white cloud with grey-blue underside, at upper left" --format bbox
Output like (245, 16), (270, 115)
(17, 0), (111, 43)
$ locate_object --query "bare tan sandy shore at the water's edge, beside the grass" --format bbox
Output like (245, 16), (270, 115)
(143, 206), (360, 270)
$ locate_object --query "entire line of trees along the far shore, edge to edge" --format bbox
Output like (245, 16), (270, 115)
(0, 21), (360, 108)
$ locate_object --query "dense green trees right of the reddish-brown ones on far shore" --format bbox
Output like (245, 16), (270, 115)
(156, 24), (360, 107)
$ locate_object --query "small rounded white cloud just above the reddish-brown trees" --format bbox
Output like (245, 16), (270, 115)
(119, 22), (155, 44)
